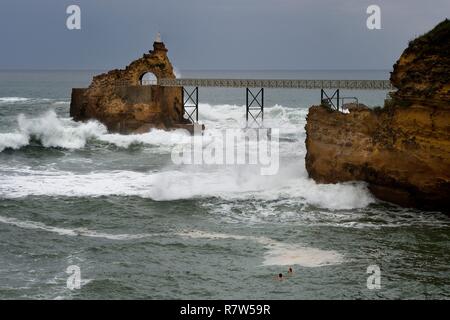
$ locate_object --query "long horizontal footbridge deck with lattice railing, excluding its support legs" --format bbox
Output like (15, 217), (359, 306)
(156, 78), (394, 90)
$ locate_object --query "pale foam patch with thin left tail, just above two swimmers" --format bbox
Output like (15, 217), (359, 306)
(176, 230), (345, 268)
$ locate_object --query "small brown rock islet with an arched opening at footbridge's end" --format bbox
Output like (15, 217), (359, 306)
(70, 42), (192, 133)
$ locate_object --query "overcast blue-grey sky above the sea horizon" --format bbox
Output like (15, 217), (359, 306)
(0, 0), (450, 70)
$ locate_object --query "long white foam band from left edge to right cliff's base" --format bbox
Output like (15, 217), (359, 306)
(0, 167), (374, 209)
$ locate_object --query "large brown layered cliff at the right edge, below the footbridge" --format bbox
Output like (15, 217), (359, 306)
(306, 20), (450, 212)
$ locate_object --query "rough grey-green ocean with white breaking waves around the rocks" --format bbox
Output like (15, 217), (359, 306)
(0, 70), (450, 299)
